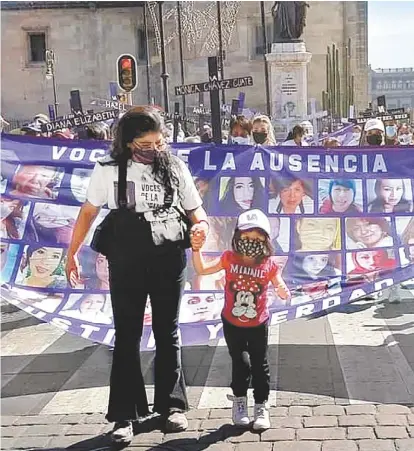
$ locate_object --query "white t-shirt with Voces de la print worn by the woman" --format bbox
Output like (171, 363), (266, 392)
(86, 155), (203, 213)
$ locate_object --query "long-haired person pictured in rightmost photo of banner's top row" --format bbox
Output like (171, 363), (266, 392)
(368, 179), (413, 213)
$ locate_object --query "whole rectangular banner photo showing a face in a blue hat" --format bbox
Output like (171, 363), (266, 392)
(318, 179), (363, 214)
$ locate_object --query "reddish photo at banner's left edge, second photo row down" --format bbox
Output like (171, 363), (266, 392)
(0, 196), (30, 240)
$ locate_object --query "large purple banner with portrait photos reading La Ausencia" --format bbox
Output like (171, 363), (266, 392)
(0, 134), (414, 349)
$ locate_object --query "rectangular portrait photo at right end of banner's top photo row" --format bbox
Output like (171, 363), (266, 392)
(367, 179), (413, 213)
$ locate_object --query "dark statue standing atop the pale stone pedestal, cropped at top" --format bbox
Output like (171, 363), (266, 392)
(272, 1), (309, 42)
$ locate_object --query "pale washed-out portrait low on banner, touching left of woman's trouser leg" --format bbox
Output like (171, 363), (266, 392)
(60, 293), (112, 324)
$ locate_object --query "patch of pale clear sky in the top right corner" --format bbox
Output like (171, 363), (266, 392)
(368, 0), (414, 69)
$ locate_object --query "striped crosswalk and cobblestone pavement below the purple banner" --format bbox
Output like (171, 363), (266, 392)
(1, 290), (414, 451)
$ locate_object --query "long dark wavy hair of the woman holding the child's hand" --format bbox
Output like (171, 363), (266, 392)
(101, 106), (179, 192)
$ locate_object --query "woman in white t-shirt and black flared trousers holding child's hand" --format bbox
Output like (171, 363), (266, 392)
(66, 107), (209, 444)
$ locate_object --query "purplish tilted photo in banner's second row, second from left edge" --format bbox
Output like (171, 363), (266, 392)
(27, 203), (80, 246)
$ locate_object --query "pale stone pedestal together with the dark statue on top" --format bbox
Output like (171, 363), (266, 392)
(266, 1), (312, 133)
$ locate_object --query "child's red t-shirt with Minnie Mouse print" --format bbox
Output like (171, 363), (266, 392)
(221, 251), (279, 327)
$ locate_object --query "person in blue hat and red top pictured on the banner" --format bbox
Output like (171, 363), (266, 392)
(319, 179), (361, 213)
